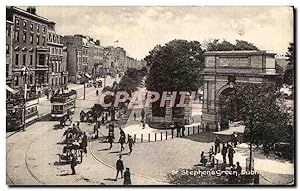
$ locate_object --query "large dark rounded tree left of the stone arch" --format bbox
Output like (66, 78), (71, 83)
(145, 40), (204, 92)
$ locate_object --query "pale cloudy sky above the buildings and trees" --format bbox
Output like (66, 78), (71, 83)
(21, 6), (293, 59)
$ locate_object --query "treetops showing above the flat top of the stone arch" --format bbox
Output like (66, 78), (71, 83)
(205, 39), (259, 51)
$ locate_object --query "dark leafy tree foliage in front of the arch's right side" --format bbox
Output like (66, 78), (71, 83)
(220, 83), (294, 157)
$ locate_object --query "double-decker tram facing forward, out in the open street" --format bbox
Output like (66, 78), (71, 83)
(50, 90), (77, 120)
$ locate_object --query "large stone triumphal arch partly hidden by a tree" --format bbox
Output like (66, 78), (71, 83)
(201, 51), (278, 131)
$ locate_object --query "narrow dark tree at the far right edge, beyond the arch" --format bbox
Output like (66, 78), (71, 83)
(283, 43), (295, 86)
